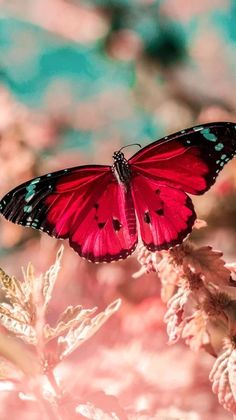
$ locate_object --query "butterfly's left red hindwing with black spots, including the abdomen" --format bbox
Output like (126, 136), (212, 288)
(69, 182), (138, 262)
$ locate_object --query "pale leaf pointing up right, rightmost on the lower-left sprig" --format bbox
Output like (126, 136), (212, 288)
(57, 299), (121, 360)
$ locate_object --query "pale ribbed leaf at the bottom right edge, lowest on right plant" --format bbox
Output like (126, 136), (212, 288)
(209, 346), (236, 414)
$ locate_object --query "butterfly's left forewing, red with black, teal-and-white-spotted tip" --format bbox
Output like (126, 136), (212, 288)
(0, 165), (110, 228)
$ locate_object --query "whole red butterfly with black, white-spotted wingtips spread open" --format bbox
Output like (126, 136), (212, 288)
(0, 122), (236, 262)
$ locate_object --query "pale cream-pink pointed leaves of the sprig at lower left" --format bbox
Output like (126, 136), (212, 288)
(0, 247), (120, 366)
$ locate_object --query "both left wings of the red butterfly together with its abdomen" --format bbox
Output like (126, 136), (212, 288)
(0, 165), (137, 262)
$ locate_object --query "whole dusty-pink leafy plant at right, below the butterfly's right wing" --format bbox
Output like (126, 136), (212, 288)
(136, 235), (236, 414)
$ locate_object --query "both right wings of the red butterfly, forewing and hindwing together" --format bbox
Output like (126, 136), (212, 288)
(129, 123), (236, 251)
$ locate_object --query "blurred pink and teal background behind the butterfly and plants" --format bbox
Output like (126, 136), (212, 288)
(0, 0), (236, 420)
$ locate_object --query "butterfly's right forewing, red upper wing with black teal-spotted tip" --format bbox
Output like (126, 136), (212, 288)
(129, 122), (236, 194)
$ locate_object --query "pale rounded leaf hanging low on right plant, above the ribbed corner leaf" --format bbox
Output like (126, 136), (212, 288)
(182, 310), (210, 351)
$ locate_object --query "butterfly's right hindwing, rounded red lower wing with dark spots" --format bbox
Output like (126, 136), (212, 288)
(132, 175), (196, 251)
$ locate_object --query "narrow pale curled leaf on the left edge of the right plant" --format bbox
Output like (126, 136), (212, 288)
(164, 287), (191, 343)
